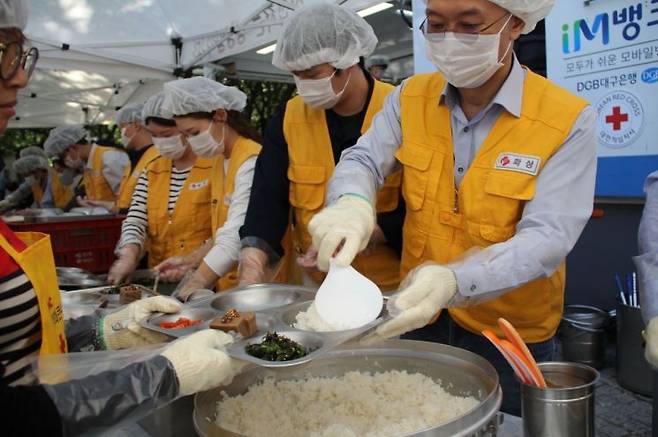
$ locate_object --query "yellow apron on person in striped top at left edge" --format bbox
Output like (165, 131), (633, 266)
(0, 232), (67, 355)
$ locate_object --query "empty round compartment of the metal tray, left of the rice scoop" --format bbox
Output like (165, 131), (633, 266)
(211, 284), (315, 311)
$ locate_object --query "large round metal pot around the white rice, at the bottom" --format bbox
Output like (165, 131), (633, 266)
(194, 340), (502, 437)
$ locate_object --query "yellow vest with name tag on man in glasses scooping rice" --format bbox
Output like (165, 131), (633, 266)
(395, 71), (587, 343)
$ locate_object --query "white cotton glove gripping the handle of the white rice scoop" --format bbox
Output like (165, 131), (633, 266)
(308, 194), (376, 272)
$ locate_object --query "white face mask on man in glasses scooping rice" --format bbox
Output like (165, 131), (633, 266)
(425, 15), (512, 88)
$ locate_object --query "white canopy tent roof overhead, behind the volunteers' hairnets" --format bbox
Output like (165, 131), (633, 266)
(10, 0), (412, 128)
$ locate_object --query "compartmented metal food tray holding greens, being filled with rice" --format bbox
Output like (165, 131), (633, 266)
(141, 284), (388, 368)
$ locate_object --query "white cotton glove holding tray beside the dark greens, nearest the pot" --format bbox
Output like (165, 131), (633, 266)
(162, 329), (243, 396)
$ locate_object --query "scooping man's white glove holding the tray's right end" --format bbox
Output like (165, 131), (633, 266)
(368, 263), (457, 341)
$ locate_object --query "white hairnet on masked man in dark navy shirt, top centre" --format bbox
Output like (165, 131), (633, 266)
(272, 3), (377, 71)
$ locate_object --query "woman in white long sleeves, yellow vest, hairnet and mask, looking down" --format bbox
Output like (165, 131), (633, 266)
(155, 77), (261, 300)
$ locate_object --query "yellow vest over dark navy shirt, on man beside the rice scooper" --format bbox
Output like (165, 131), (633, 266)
(283, 81), (402, 290)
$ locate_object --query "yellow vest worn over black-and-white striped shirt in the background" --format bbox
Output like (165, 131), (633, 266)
(146, 156), (213, 267)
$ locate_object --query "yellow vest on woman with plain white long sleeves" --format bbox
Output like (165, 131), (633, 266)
(210, 137), (261, 291)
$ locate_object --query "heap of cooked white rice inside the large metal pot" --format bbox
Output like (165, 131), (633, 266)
(216, 370), (478, 437)
